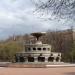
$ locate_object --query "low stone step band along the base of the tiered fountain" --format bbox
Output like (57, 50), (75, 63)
(0, 63), (75, 68)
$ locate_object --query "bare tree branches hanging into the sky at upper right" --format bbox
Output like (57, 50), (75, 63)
(33, 0), (75, 20)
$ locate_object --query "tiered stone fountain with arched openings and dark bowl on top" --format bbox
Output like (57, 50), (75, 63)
(15, 32), (61, 63)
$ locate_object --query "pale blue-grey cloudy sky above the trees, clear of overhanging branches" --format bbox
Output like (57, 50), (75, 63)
(0, 0), (75, 39)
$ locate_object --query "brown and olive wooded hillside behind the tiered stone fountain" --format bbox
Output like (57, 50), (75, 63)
(0, 29), (75, 62)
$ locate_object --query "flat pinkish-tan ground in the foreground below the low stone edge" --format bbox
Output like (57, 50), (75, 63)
(0, 67), (75, 75)
